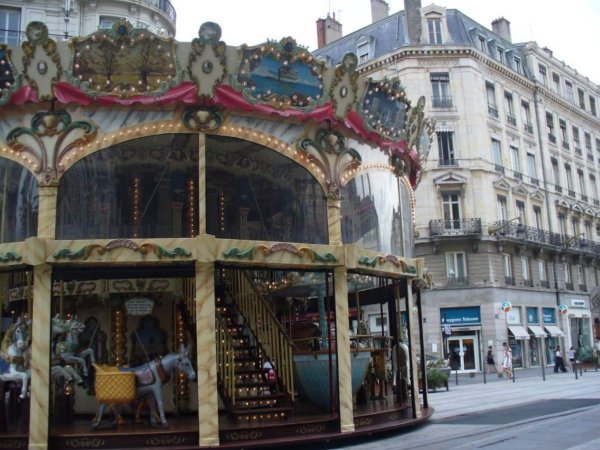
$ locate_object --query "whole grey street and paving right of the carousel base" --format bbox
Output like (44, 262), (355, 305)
(300, 369), (600, 450)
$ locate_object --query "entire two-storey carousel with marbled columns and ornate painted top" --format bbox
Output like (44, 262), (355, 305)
(0, 21), (433, 450)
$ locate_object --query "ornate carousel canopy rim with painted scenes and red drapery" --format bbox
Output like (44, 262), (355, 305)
(0, 21), (433, 186)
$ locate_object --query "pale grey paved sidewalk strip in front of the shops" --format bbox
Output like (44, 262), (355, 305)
(428, 368), (600, 421)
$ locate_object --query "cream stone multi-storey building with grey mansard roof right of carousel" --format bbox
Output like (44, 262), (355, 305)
(315, 0), (600, 372)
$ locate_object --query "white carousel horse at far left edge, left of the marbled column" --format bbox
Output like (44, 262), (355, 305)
(0, 318), (31, 398)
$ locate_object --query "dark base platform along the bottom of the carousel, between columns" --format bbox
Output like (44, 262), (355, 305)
(5, 396), (434, 450)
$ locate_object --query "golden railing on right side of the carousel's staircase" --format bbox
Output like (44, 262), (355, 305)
(224, 268), (294, 400)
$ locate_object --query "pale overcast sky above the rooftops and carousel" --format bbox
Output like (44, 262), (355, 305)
(171, 0), (600, 84)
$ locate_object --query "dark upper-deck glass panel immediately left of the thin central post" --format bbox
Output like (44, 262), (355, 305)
(56, 134), (198, 239)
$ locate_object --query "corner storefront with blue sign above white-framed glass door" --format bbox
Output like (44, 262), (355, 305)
(440, 306), (482, 372)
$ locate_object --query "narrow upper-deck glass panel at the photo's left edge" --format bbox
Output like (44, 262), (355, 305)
(0, 158), (38, 243)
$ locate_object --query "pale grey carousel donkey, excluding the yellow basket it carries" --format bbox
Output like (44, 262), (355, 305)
(92, 344), (196, 428)
